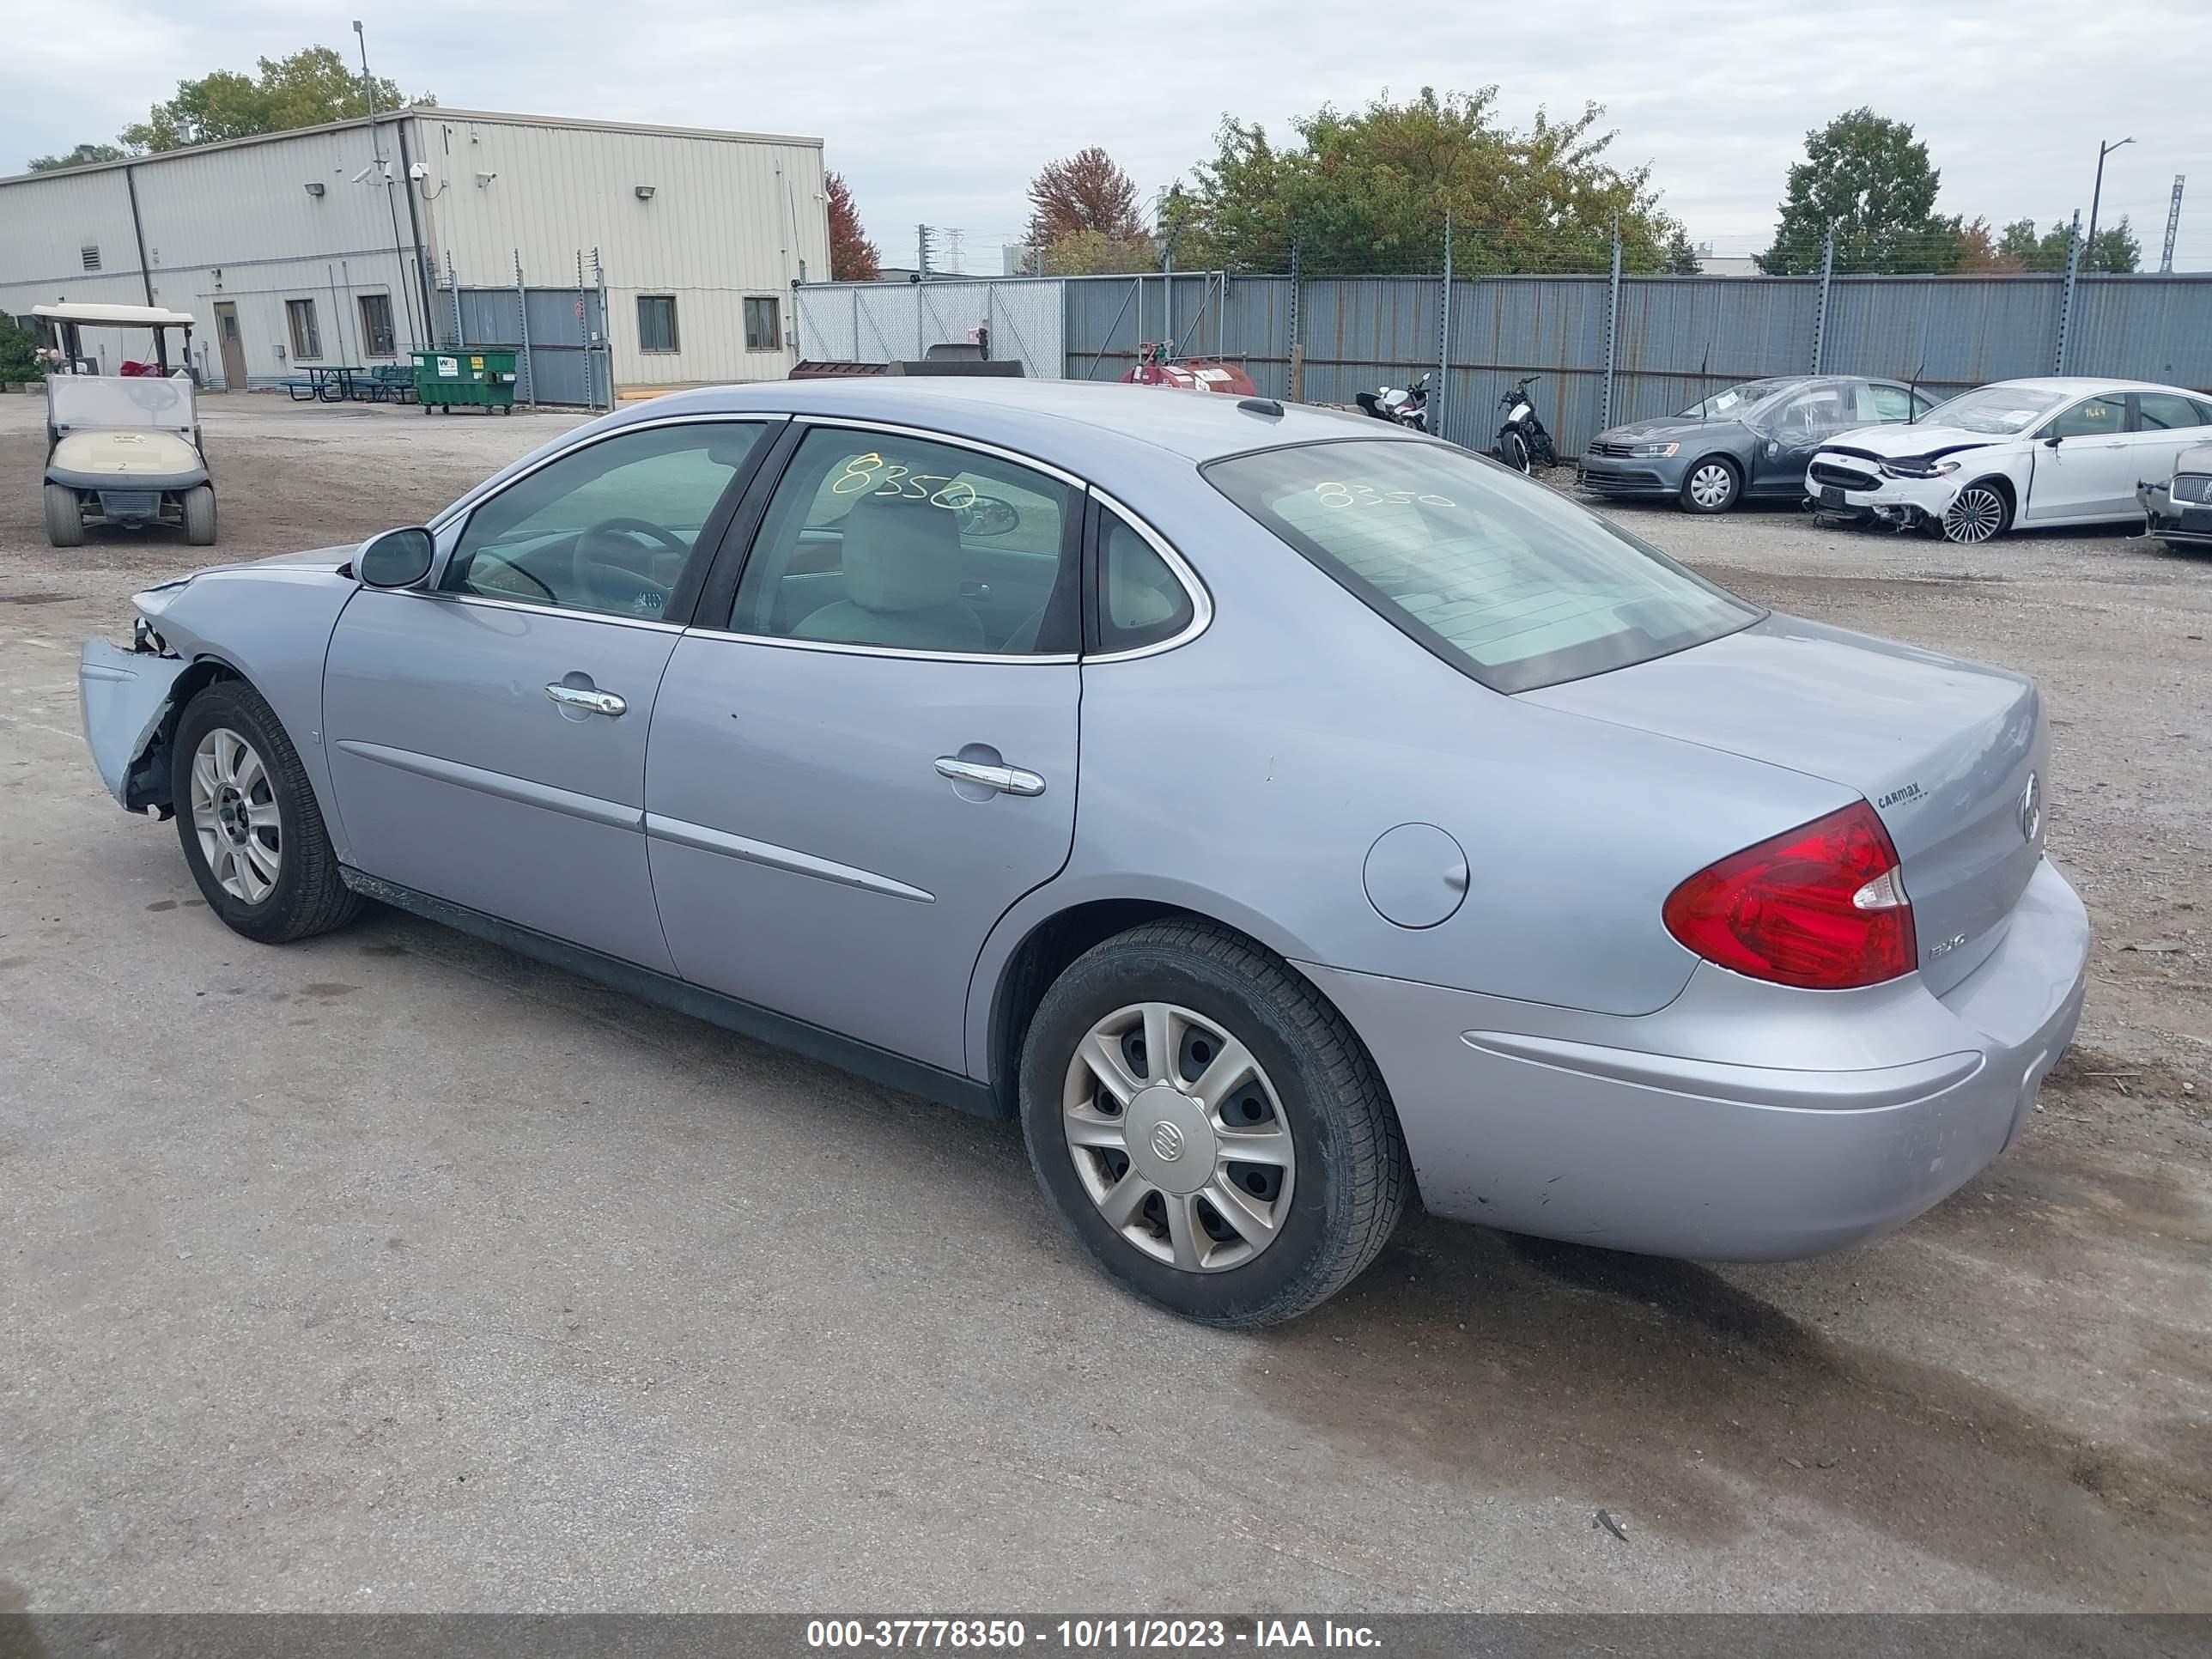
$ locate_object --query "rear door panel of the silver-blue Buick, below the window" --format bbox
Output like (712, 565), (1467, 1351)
(646, 635), (1079, 1071)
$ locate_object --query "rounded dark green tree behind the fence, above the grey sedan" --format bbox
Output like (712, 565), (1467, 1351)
(1759, 108), (1962, 274)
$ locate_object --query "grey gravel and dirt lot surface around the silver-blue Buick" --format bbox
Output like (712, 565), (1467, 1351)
(0, 396), (2212, 1610)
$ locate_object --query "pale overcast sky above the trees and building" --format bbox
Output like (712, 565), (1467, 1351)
(13, 0), (2212, 270)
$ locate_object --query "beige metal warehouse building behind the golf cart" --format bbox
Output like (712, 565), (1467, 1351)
(0, 108), (830, 403)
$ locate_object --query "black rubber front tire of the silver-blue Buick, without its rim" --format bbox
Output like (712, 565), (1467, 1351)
(170, 679), (361, 945)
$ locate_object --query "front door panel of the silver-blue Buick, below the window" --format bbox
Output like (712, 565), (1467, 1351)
(323, 588), (677, 973)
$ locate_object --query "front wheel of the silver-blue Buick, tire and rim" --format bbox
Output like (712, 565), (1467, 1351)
(170, 679), (361, 945)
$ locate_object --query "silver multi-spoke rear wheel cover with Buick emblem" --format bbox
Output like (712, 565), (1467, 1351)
(1060, 1002), (1297, 1274)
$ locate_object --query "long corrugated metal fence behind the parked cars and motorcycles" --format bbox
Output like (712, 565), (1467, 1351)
(799, 272), (2212, 453)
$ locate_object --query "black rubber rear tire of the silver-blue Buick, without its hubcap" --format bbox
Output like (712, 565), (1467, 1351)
(1022, 921), (1413, 1329)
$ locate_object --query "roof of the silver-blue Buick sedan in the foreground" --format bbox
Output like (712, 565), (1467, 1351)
(610, 376), (1418, 462)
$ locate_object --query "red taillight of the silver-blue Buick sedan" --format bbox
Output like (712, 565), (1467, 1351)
(1663, 801), (1917, 991)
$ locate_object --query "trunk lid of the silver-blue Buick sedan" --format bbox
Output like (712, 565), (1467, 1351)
(1520, 617), (2051, 995)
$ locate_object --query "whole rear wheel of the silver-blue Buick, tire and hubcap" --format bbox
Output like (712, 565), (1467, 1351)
(1022, 922), (1411, 1329)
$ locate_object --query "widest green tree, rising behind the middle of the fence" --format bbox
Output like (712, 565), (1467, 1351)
(1164, 86), (1687, 274)
